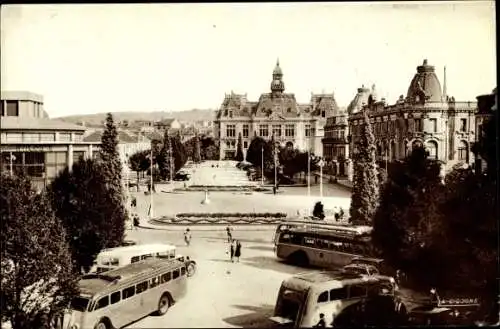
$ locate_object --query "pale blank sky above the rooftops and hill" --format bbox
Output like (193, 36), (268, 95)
(0, 1), (497, 117)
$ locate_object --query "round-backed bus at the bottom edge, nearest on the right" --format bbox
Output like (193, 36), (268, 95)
(270, 271), (406, 328)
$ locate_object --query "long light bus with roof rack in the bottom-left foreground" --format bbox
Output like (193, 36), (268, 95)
(63, 258), (187, 329)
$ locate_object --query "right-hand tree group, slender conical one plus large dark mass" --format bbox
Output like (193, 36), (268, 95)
(350, 111), (498, 316)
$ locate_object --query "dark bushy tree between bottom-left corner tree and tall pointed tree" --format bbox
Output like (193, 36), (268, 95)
(48, 159), (127, 271)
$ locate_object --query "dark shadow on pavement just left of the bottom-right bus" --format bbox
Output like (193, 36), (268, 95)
(222, 305), (274, 328)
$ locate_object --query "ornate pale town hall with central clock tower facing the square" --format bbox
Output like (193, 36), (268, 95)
(214, 61), (338, 159)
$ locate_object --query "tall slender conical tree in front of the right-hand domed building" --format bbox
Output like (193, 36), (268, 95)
(349, 110), (379, 224)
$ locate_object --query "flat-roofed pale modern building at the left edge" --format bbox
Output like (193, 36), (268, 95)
(0, 91), (93, 189)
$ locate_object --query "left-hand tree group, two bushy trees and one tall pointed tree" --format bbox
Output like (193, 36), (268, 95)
(0, 114), (128, 329)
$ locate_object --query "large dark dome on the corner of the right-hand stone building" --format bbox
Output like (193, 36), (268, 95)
(406, 59), (442, 104)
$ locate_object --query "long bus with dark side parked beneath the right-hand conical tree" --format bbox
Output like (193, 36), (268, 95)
(275, 223), (374, 268)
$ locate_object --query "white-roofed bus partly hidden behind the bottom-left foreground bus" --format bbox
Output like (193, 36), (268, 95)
(90, 243), (196, 276)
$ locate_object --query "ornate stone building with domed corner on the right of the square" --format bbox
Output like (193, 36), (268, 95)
(348, 60), (477, 170)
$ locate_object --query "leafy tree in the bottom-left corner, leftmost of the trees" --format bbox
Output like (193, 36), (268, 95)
(0, 174), (78, 329)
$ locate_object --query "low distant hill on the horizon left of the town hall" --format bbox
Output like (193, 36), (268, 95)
(57, 109), (215, 125)
